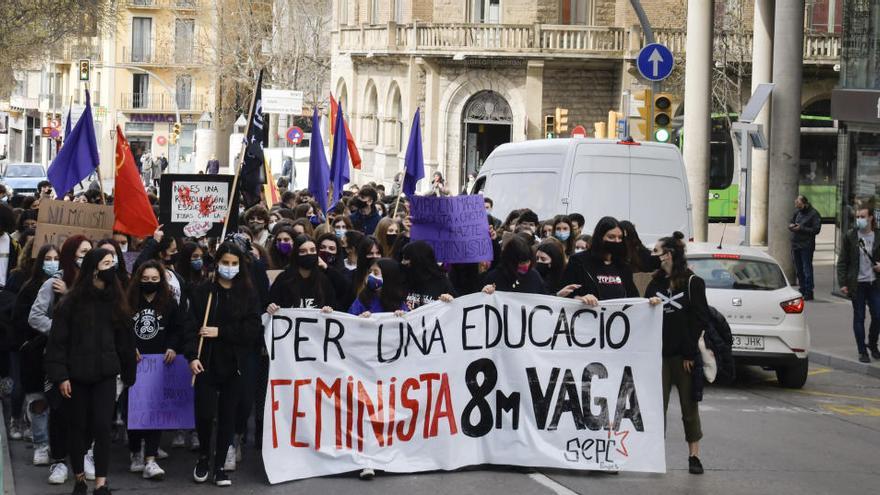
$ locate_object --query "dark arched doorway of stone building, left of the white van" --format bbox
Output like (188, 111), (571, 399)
(460, 90), (513, 184)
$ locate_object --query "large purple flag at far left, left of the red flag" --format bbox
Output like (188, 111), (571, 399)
(46, 90), (100, 195)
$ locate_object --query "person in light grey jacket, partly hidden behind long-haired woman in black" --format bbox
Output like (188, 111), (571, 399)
(28, 235), (93, 485)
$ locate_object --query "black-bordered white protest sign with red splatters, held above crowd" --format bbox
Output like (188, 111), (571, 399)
(159, 174), (237, 238)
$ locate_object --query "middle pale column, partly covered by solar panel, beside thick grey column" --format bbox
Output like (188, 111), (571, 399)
(750, 0), (776, 245)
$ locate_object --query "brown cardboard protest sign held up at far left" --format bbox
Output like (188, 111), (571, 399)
(31, 199), (114, 257)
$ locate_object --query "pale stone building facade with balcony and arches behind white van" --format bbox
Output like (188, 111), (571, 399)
(330, 0), (839, 190)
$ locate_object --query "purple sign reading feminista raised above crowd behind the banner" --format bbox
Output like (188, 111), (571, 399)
(410, 196), (492, 263)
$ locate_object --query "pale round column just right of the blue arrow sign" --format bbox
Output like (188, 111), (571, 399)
(684, 0), (715, 241)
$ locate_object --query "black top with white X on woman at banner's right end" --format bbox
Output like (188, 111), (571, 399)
(645, 275), (709, 360)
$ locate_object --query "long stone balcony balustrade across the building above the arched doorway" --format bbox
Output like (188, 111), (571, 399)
(334, 22), (840, 64)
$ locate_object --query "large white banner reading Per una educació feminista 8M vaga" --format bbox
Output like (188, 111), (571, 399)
(263, 293), (666, 483)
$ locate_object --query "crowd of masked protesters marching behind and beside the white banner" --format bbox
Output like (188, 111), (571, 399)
(0, 181), (707, 494)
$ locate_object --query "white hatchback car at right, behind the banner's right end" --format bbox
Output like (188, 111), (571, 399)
(687, 243), (810, 388)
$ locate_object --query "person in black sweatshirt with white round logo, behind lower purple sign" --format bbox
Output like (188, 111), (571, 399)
(122, 260), (191, 480)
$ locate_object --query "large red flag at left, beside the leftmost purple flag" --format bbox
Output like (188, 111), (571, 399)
(113, 126), (159, 237)
